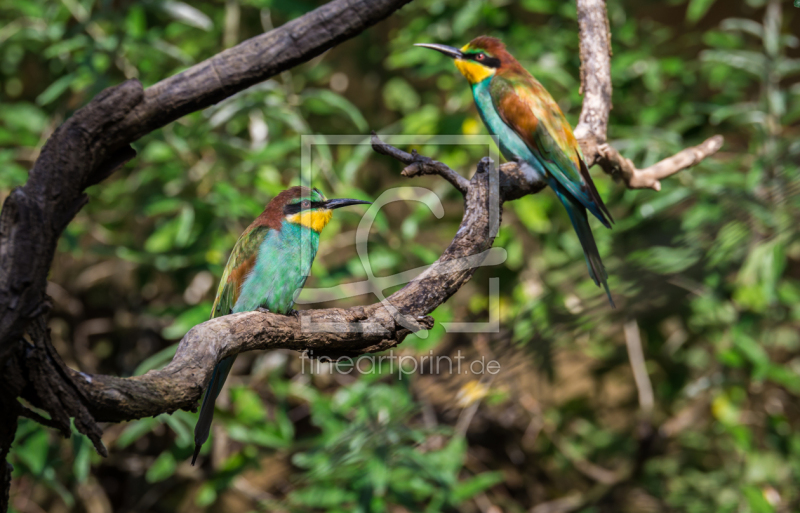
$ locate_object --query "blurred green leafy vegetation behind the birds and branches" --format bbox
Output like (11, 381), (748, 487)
(0, 0), (800, 513)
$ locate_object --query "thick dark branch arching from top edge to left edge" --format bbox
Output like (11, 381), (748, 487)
(0, 0), (410, 367)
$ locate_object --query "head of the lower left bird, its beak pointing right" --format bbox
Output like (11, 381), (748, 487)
(263, 186), (371, 233)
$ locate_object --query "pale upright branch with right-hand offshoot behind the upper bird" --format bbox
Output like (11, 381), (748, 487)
(575, 0), (724, 191)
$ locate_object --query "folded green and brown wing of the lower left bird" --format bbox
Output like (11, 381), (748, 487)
(211, 226), (271, 318)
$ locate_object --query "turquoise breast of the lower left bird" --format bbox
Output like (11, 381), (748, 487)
(233, 221), (319, 314)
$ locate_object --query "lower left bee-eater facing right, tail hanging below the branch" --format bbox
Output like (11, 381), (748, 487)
(192, 186), (370, 465)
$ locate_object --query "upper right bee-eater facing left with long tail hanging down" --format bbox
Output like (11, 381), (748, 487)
(416, 36), (614, 307)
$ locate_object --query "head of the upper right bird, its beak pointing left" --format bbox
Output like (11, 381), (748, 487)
(414, 36), (516, 84)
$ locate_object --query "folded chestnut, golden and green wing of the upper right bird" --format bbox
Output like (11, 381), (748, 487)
(490, 75), (611, 226)
